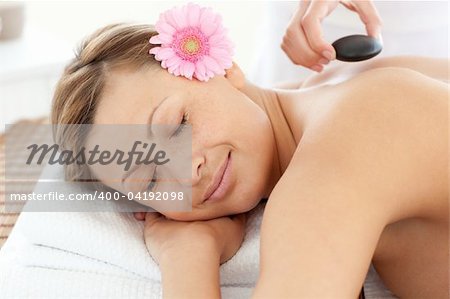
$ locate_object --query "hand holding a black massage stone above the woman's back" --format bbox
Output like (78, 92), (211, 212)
(281, 0), (381, 72)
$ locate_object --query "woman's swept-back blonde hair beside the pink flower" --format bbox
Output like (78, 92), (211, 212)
(51, 23), (159, 185)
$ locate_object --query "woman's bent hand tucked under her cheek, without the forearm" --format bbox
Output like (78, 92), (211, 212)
(140, 212), (246, 263)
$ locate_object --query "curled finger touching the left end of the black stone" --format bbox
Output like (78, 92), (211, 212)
(301, 1), (338, 60)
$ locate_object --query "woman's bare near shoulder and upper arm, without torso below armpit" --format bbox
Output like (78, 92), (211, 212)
(254, 68), (448, 298)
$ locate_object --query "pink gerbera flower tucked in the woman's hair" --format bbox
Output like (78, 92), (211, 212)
(149, 3), (233, 81)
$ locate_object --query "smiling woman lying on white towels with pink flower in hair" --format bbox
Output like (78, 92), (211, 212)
(52, 7), (449, 298)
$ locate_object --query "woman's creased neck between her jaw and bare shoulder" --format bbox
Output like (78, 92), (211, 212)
(240, 81), (297, 197)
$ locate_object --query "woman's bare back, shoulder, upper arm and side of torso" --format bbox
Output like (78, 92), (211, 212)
(255, 59), (449, 298)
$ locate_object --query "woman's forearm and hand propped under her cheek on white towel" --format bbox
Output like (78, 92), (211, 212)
(140, 212), (246, 299)
